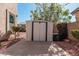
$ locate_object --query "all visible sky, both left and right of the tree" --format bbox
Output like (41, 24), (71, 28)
(17, 3), (79, 23)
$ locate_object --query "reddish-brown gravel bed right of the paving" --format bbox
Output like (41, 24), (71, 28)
(55, 41), (79, 56)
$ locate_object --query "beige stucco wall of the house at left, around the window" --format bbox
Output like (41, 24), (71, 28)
(0, 3), (17, 33)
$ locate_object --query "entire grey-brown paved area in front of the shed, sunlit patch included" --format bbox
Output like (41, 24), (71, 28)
(1, 39), (69, 56)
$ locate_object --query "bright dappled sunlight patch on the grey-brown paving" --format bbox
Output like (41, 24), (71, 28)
(48, 43), (70, 56)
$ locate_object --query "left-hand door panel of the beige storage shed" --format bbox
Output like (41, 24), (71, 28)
(33, 22), (40, 41)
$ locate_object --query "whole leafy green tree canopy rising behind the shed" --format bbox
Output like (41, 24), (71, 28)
(31, 3), (71, 23)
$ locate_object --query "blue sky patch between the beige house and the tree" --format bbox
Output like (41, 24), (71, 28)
(18, 3), (35, 23)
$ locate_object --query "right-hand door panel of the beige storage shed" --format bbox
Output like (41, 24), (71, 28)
(39, 23), (46, 41)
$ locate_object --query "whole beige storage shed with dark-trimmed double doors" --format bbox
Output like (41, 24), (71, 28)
(26, 21), (53, 41)
